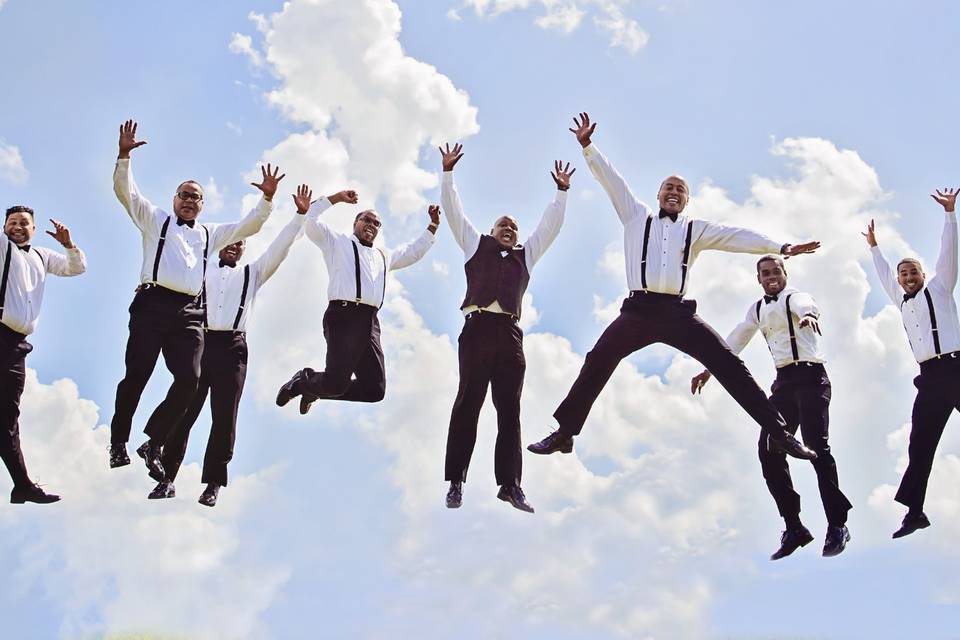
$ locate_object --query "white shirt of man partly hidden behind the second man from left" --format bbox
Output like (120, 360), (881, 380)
(206, 214), (307, 331)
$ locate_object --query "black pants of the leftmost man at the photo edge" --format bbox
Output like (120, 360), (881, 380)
(0, 324), (33, 487)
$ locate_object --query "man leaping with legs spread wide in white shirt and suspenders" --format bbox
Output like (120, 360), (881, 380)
(528, 113), (820, 459)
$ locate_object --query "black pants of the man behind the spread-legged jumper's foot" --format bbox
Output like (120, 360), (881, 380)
(759, 362), (853, 526)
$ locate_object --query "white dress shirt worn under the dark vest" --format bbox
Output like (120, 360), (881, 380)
(440, 171), (567, 315)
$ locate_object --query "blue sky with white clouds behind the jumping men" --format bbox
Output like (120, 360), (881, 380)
(0, 0), (960, 640)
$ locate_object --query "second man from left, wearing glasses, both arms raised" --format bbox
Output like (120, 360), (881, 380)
(110, 120), (283, 482)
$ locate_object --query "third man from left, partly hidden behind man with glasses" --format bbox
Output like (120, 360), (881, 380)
(148, 185), (313, 507)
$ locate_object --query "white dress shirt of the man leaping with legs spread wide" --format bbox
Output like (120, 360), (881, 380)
(583, 144), (784, 295)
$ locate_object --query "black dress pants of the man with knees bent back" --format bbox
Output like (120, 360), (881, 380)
(297, 300), (387, 402)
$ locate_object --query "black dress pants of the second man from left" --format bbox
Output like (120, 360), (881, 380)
(110, 286), (203, 445)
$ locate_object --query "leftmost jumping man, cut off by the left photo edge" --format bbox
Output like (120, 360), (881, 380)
(0, 205), (87, 504)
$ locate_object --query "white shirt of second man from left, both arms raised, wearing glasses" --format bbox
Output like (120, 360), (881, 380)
(113, 158), (273, 296)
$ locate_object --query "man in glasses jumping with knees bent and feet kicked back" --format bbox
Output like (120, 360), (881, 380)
(277, 191), (440, 414)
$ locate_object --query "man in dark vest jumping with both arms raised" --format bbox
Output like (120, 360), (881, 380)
(440, 144), (576, 513)
